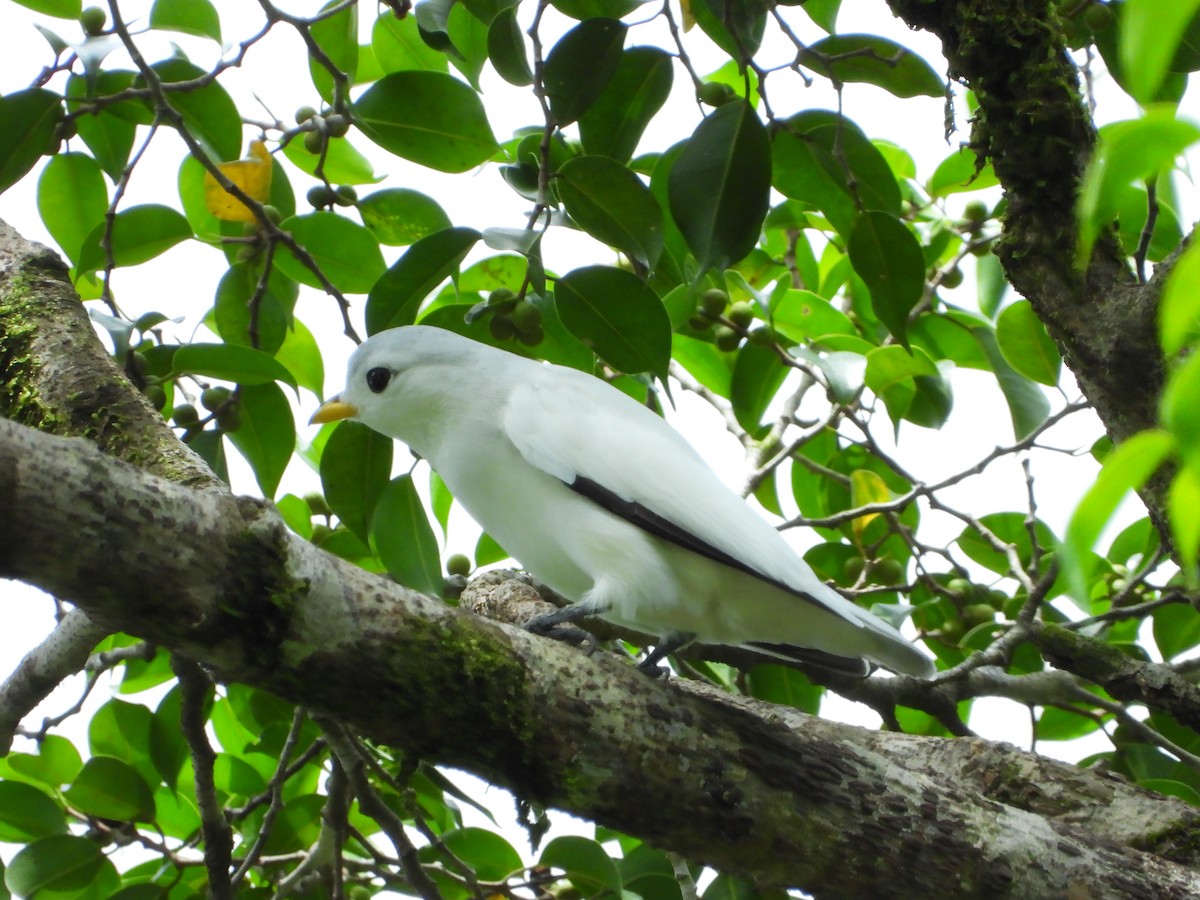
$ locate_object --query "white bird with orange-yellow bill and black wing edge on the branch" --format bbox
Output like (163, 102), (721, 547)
(312, 325), (934, 677)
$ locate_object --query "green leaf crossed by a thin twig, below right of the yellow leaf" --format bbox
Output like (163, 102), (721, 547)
(275, 211), (386, 294)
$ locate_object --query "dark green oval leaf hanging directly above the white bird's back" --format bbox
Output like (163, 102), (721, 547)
(554, 265), (671, 380)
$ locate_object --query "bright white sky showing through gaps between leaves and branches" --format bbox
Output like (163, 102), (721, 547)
(0, 0), (1200, 873)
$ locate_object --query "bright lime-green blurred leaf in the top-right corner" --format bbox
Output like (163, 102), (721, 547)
(1117, 0), (1200, 104)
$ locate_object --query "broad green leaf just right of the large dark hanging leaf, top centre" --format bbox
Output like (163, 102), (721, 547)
(772, 109), (900, 237)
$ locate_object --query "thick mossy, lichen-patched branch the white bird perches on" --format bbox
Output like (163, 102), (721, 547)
(0, 421), (1200, 898)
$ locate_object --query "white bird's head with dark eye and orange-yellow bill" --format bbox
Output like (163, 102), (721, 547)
(310, 325), (515, 451)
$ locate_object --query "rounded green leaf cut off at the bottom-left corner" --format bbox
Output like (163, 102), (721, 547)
(5, 834), (120, 898)
